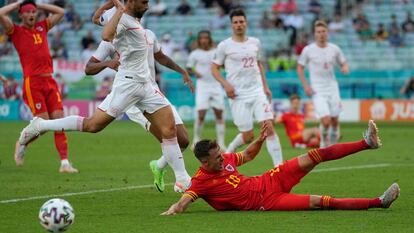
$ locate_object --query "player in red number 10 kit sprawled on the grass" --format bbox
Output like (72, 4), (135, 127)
(162, 121), (400, 215)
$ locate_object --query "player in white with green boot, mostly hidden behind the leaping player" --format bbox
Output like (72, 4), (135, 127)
(85, 1), (189, 192)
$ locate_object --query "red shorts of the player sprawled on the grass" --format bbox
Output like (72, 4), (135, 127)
(262, 158), (310, 210)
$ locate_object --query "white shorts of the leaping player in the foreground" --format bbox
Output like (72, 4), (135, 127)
(98, 74), (170, 118)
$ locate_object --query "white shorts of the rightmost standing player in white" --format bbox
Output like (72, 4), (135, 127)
(312, 93), (342, 119)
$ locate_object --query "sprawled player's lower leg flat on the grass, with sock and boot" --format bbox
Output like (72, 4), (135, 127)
(311, 183), (400, 210)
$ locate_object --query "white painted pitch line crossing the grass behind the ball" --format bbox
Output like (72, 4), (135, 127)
(0, 163), (392, 204)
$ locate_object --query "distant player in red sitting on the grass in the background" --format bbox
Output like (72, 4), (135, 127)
(277, 94), (320, 148)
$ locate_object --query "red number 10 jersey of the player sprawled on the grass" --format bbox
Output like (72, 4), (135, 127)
(184, 153), (264, 210)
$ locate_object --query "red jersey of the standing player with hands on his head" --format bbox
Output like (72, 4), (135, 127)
(8, 19), (53, 77)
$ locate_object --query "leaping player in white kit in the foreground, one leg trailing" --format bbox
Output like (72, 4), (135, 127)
(19, 0), (193, 191)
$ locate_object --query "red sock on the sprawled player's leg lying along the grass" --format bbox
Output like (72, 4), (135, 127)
(321, 196), (381, 210)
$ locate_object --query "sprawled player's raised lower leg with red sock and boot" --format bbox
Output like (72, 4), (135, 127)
(308, 120), (381, 165)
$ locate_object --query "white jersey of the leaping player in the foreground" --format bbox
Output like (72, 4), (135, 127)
(113, 14), (151, 82)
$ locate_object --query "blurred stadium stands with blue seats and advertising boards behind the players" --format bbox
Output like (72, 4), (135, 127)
(0, 0), (414, 122)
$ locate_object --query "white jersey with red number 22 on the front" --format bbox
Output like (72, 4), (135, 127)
(213, 37), (264, 99)
